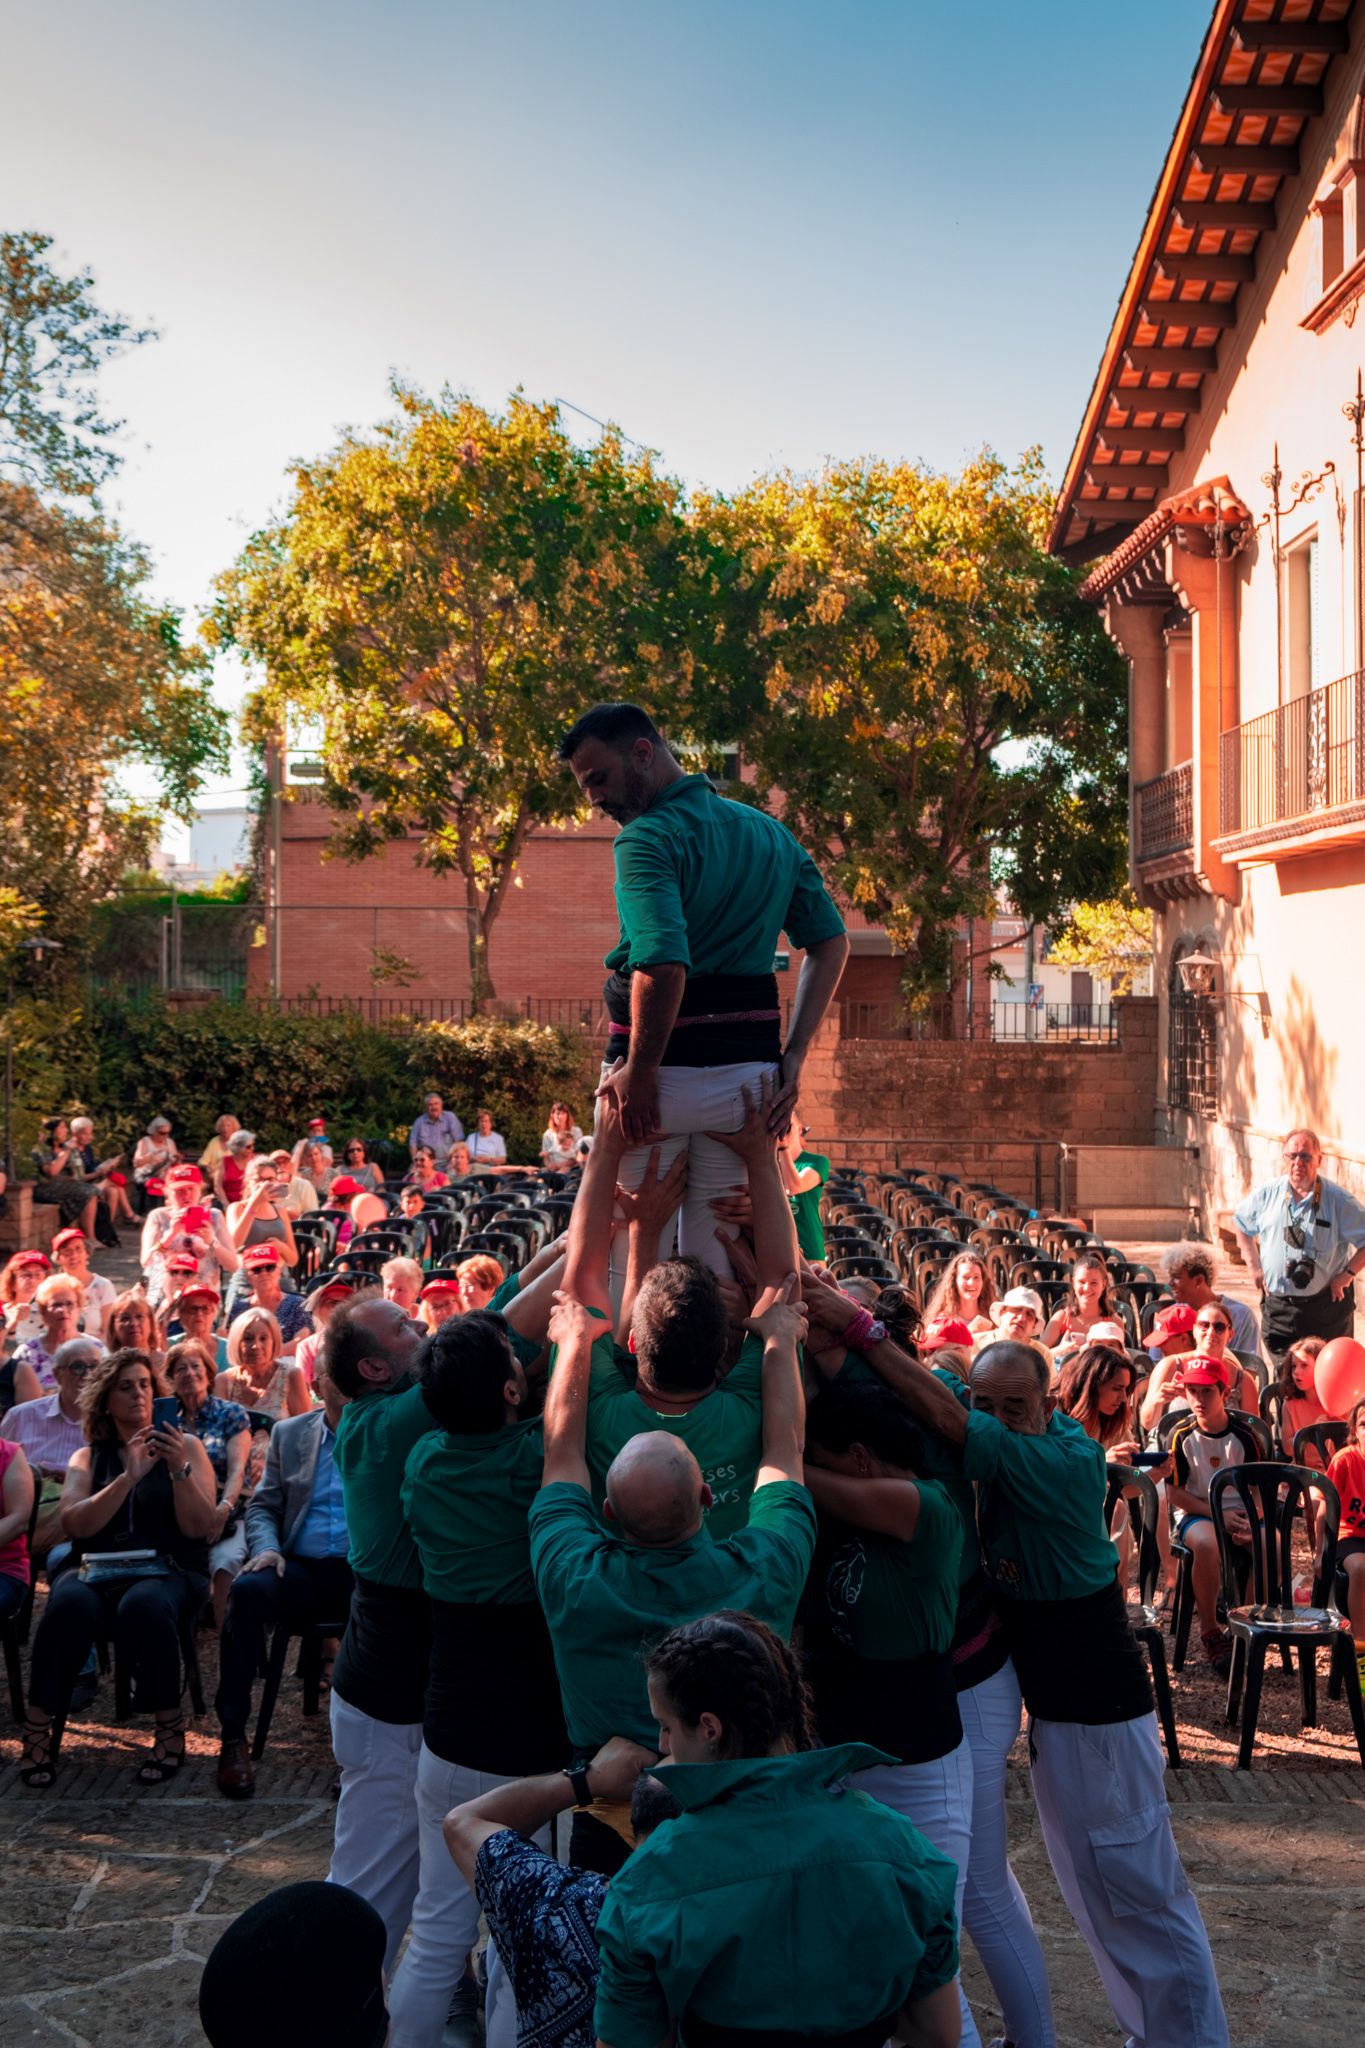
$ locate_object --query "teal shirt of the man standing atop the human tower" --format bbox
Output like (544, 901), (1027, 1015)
(606, 774), (843, 975)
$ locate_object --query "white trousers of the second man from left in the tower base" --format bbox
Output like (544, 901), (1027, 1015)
(389, 1743), (551, 2048)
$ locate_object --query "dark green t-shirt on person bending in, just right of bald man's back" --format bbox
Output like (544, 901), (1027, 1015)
(823, 1479), (962, 1661)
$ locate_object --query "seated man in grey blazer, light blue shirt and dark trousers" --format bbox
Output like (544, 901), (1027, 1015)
(213, 1374), (350, 1798)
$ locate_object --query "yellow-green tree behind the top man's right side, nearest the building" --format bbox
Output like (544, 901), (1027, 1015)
(698, 455), (1126, 993)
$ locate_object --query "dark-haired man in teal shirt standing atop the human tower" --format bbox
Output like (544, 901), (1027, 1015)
(559, 705), (849, 1277)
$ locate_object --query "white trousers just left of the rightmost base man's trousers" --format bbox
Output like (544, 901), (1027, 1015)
(958, 1663), (1056, 2048)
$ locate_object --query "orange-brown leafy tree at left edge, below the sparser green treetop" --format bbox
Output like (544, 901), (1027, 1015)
(0, 481), (227, 965)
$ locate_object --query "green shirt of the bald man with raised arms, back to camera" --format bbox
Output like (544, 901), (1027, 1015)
(530, 1479), (814, 1755)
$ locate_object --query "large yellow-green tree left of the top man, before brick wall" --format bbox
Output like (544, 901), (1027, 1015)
(215, 385), (731, 1004)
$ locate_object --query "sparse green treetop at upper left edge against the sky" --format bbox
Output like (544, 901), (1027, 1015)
(0, 233), (153, 501)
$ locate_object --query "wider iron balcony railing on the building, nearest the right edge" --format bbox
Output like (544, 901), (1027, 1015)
(1218, 670), (1365, 840)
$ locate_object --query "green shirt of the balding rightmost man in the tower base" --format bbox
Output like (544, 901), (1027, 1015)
(962, 1413), (1119, 1599)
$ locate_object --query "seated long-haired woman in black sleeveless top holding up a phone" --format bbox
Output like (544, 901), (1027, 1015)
(20, 1350), (219, 1790)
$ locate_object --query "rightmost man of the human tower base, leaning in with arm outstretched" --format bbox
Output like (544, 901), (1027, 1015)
(868, 1341), (1228, 2048)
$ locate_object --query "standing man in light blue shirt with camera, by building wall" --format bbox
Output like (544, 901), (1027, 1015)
(1232, 1130), (1365, 1360)
